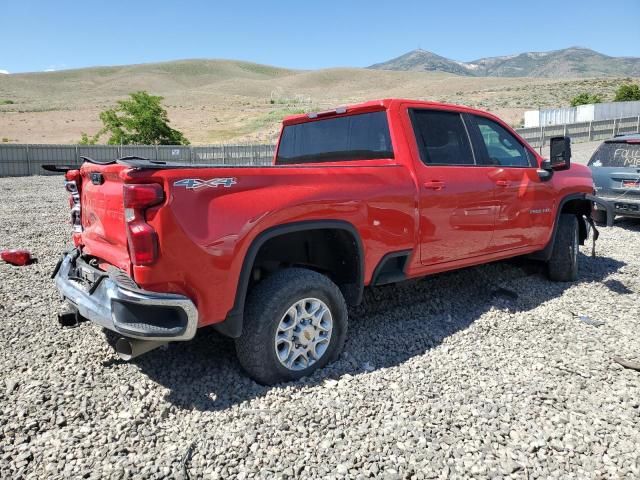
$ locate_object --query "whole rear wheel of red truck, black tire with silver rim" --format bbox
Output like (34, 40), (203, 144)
(236, 268), (347, 385)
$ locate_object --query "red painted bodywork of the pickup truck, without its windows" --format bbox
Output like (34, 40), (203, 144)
(67, 99), (593, 332)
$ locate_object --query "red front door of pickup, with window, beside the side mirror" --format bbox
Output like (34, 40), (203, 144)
(465, 115), (555, 252)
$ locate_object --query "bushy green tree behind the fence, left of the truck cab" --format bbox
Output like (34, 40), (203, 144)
(80, 91), (189, 145)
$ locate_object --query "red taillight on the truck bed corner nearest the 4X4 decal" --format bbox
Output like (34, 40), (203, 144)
(123, 183), (164, 265)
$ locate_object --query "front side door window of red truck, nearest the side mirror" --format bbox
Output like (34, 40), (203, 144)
(468, 115), (535, 167)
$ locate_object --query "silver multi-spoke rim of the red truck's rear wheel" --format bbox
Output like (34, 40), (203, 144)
(274, 298), (333, 371)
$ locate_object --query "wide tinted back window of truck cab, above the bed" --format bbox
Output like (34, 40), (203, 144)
(276, 111), (393, 165)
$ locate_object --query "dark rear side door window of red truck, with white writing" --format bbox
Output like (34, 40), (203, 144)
(410, 109), (475, 165)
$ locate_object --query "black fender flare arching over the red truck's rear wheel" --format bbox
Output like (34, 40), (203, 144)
(213, 220), (364, 338)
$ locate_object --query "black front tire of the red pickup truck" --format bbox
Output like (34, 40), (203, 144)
(547, 213), (579, 282)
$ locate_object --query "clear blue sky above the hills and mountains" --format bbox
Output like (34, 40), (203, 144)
(0, 0), (640, 72)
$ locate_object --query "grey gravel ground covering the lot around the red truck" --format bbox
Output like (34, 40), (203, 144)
(0, 177), (640, 479)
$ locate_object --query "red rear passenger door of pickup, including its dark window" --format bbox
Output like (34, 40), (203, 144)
(409, 108), (496, 265)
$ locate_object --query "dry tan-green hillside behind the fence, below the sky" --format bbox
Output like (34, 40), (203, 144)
(0, 54), (636, 143)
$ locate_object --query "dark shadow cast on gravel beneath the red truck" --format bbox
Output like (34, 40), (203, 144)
(129, 254), (624, 411)
